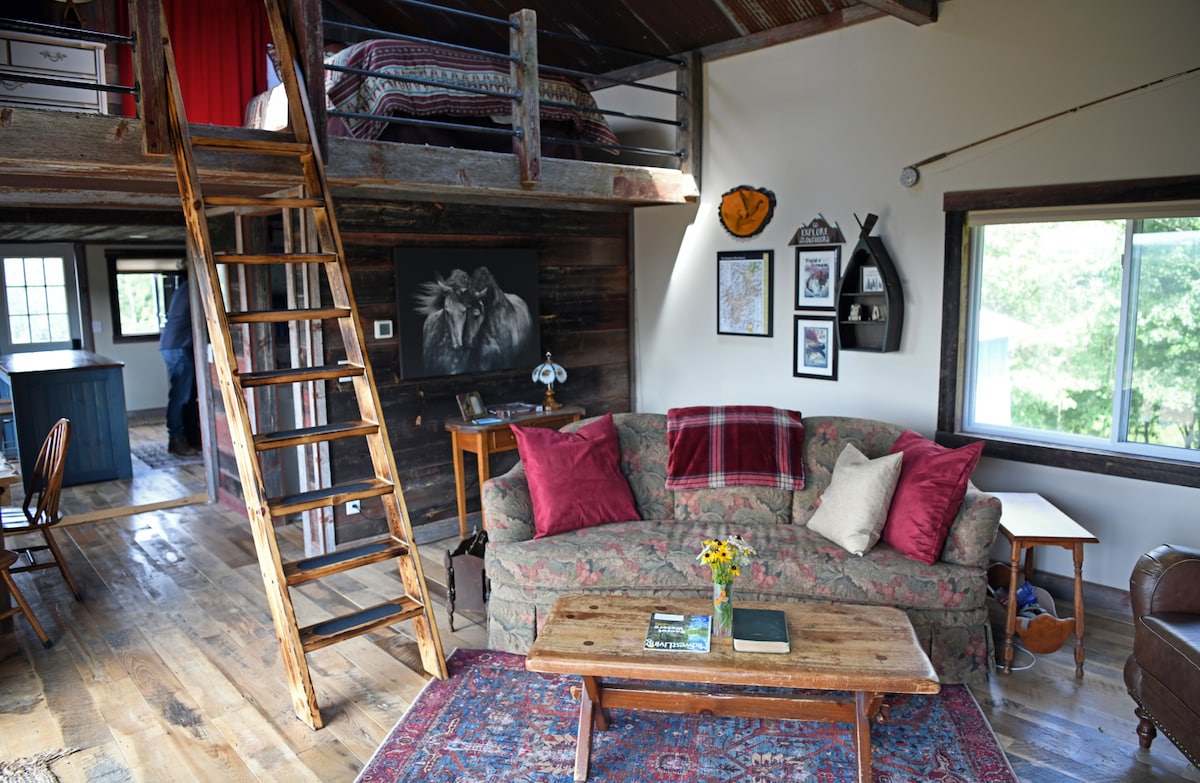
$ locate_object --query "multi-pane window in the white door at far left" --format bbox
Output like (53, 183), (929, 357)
(0, 245), (78, 353)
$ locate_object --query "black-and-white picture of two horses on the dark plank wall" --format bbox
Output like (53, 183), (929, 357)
(395, 247), (541, 378)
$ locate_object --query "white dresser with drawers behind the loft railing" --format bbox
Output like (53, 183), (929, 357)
(0, 30), (108, 114)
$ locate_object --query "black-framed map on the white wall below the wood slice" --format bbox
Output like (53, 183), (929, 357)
(716, 250), (775, 337)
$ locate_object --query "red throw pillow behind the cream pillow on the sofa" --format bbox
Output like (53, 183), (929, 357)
(880, 430), (983, 566)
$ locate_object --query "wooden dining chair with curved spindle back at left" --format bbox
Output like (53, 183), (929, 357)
(0, 419), (83, 600)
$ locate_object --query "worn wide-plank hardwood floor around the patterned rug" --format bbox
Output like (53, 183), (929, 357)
(0, 456), (1200, 783)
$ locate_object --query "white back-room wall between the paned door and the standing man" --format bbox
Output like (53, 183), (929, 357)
(84, 245), (178, 413)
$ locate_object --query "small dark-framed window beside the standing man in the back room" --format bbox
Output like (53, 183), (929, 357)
(108, 251), (184, 342)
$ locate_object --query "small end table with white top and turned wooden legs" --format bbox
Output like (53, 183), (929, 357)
(991, 492), (1100, 677)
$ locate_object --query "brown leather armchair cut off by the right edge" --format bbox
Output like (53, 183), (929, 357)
(1124, 544), (1200, 766)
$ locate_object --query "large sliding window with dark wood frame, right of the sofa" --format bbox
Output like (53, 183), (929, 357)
(938, 175), (1200, 486)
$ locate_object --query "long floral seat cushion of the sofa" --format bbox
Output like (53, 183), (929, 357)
(486, 520), (986, 612)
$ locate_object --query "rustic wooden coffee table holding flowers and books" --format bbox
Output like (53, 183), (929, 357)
(526, 594), (941, 783)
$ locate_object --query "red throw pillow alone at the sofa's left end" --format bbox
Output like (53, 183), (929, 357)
(512, 413), (641, 538)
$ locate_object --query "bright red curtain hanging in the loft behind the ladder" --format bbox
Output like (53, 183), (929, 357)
(118, 0), (271, 126)
